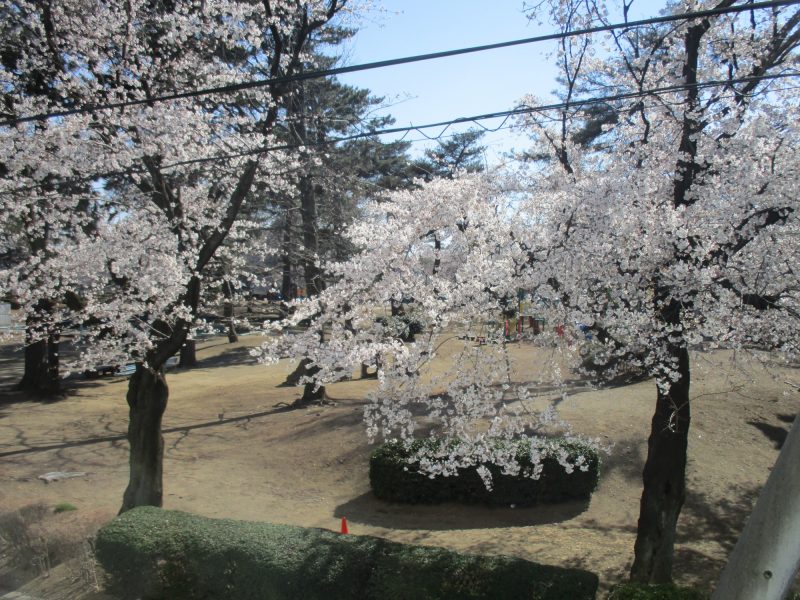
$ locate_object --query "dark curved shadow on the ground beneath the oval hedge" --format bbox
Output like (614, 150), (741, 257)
(333, 492), (589, 531)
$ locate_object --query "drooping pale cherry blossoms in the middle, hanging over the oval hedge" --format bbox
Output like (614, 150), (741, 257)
(258, 172), (595, 496)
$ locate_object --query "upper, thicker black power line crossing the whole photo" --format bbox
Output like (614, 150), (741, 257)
(0, 0), (800, 127)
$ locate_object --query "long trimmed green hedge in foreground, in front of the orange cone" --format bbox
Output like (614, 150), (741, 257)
(96, 507), (598, 600)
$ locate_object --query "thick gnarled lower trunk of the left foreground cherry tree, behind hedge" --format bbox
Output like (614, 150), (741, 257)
(119, 363), (169, 514)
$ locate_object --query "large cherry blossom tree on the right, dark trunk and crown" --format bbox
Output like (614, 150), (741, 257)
(524, 0), (800, 582)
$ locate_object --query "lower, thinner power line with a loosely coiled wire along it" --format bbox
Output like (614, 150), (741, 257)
(0, 71), (800, 195)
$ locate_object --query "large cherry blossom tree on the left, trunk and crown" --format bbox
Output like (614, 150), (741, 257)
(0, 0), (347, 510)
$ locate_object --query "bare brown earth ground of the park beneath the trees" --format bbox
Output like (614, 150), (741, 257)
(0, 336), (800, 599)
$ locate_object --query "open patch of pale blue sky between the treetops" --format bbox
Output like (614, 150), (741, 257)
(341, 0), (556, 163)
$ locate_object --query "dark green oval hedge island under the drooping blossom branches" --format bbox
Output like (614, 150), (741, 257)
(369, 439), (600, 506)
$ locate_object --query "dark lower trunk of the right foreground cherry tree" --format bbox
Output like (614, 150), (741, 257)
(631, 347), (691, 583)
